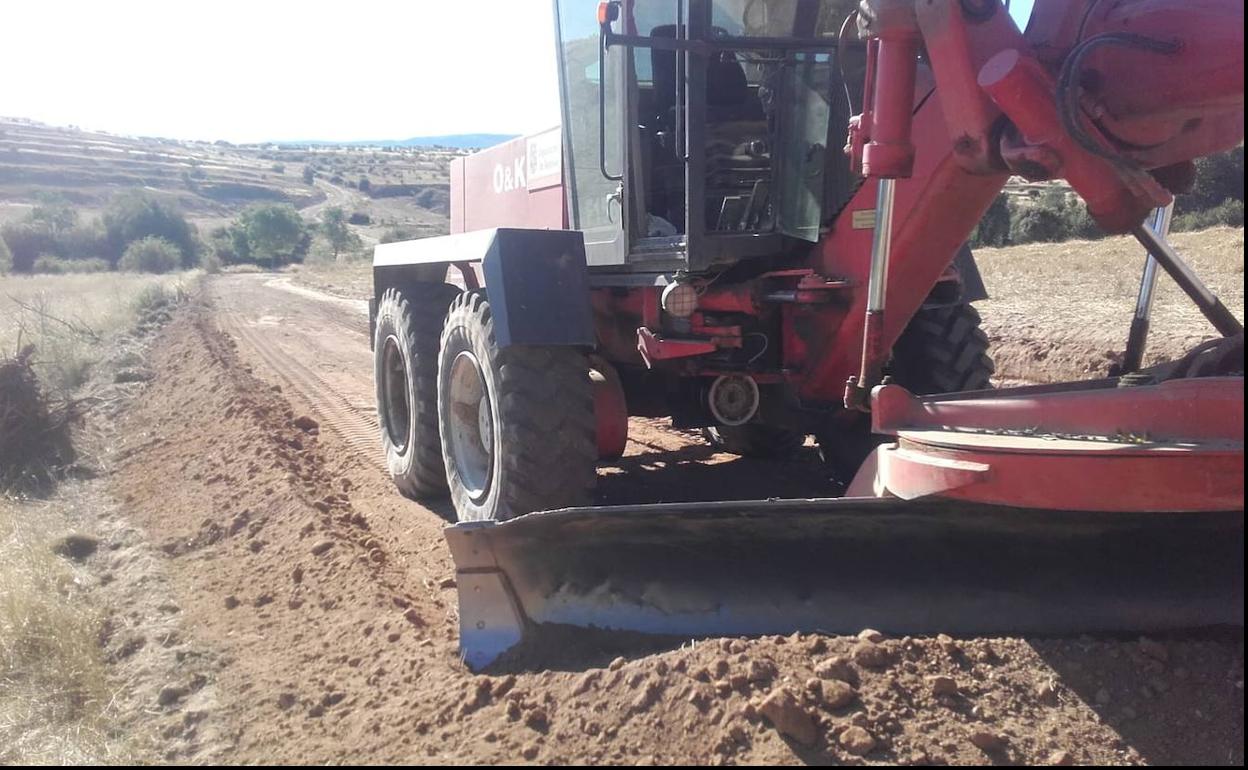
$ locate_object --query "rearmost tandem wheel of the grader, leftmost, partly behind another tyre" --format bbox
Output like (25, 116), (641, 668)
(373, 283), (459, 499)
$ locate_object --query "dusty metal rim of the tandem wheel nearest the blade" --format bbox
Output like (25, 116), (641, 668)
(447, 351), (494, 503)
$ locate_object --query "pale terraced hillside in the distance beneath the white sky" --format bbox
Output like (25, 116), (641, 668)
(0, 117), (462, 242)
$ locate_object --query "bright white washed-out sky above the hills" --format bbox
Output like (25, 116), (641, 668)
(0, 0), (1032, 142)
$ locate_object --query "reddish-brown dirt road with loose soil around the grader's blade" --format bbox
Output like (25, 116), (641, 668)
(104, 276), (1243, 764)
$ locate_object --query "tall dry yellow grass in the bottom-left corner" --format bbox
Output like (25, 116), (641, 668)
(0, 499), (129, 765)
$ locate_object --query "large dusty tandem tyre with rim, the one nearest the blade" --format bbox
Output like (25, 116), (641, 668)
(438, 291), (598, 522)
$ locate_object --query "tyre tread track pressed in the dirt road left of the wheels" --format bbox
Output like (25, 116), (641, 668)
(220, 303), (384, 469)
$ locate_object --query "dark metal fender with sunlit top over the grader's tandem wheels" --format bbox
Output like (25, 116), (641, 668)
(373, 227), (594, 347)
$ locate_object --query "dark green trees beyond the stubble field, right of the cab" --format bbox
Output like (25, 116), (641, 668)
(971, 145), (1244, 246)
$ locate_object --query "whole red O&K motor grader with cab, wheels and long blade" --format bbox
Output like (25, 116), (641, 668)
(371, 0), (1244, 668)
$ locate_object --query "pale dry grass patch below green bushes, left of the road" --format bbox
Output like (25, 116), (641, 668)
(0, 272), (197, 396)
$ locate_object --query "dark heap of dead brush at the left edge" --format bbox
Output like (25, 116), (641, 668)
(0, 346), (74, 490)
